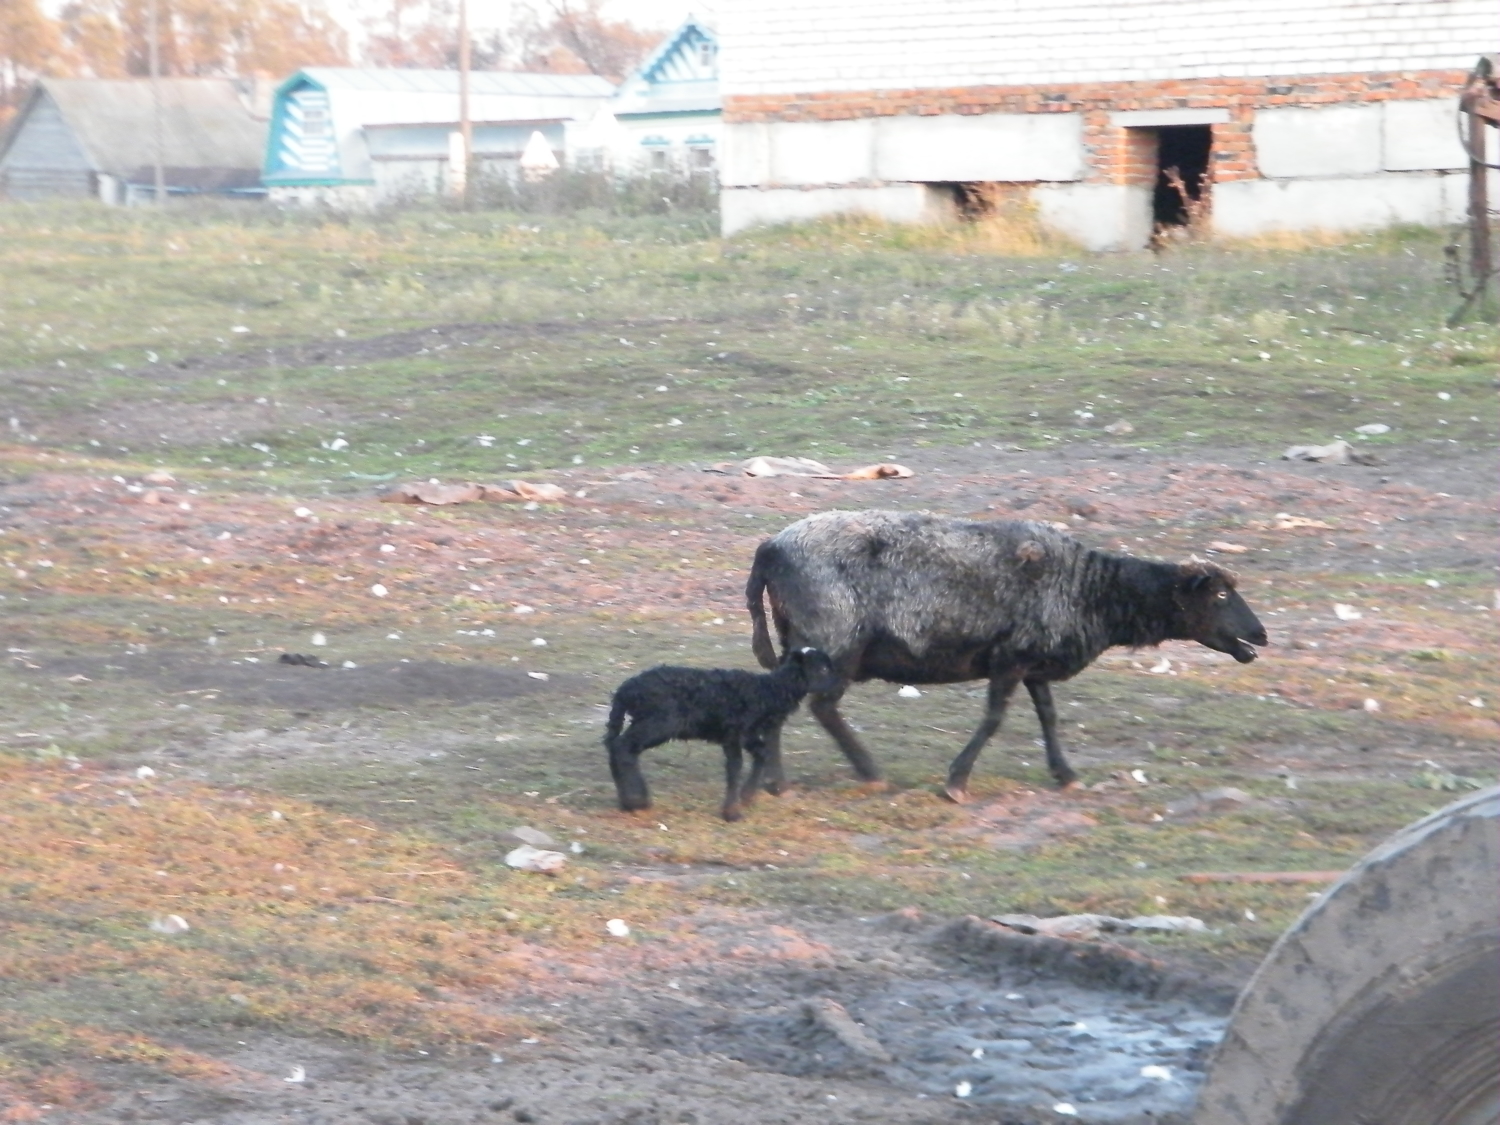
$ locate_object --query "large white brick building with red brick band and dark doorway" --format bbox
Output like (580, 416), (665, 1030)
(719, 0), (1500, 251)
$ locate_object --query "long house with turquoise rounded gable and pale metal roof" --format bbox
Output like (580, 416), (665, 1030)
(264, 66), (615, 207)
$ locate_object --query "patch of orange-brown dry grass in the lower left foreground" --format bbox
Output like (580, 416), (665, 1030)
(0, 758), (687, 1070)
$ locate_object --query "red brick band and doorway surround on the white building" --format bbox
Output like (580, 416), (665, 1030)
(725, 71), (1466, 185)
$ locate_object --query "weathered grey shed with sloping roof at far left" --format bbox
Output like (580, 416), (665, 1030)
(0, 78), (269, 204)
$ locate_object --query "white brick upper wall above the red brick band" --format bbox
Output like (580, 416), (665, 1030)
(717, 0), (1500, 98)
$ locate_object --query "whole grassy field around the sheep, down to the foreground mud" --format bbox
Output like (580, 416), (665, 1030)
(0, 212), (1500, 1121)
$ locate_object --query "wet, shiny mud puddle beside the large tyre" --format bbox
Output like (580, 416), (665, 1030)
(636, 920), (1233, 1122)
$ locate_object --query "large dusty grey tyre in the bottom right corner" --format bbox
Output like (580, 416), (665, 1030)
(1194, 788), (1500, 1125)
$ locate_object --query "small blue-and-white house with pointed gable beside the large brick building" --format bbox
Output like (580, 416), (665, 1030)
(582, 17), (720, 174)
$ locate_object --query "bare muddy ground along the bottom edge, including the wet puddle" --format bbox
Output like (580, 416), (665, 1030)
(61, 911), (1236, 1125)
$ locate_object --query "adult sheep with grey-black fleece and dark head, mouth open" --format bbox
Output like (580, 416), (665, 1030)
(746, 512), (1266, 803)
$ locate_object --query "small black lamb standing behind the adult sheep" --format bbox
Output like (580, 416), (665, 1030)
(605, 648), (839, 821)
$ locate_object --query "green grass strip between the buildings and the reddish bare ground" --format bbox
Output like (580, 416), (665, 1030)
(0, 207), (1497, 485)
